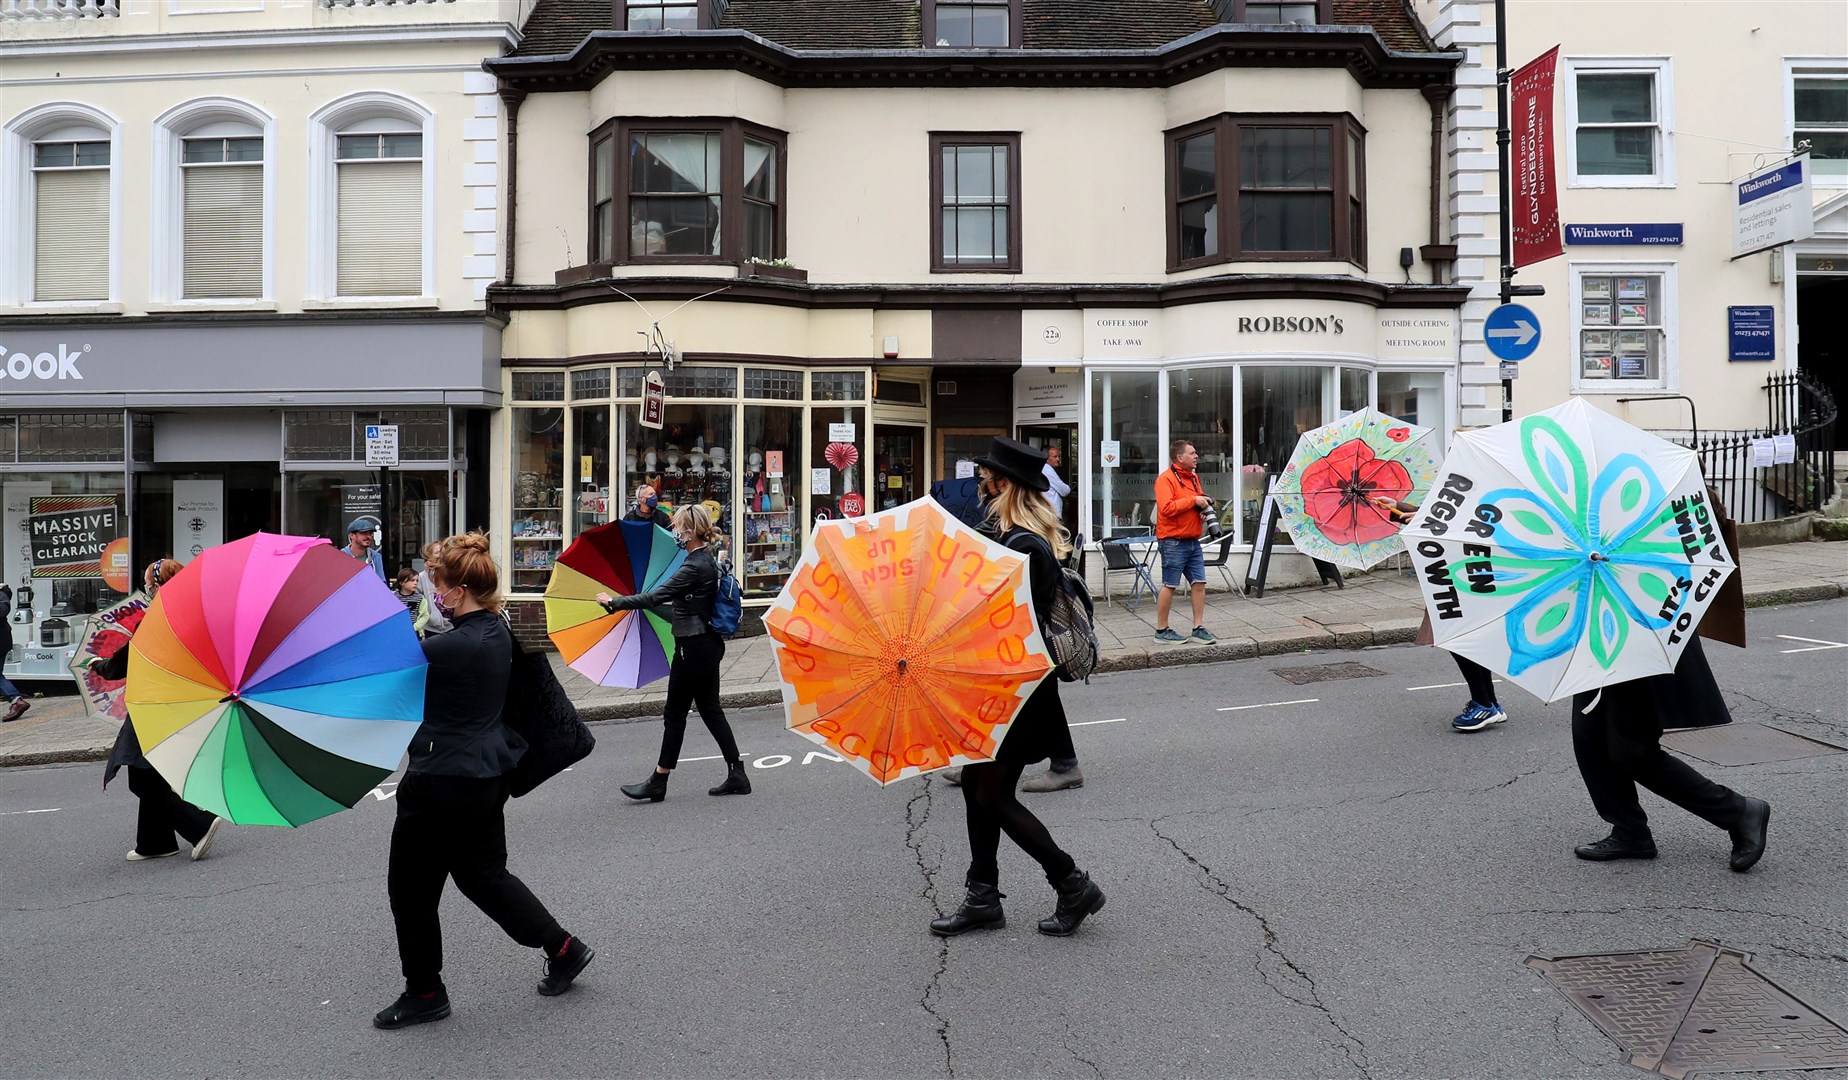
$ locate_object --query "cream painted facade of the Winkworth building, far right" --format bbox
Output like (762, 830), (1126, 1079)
(1419, 0), (1848, 431)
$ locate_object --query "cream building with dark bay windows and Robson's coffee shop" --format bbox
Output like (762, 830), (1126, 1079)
(486, 0), (1467, 623)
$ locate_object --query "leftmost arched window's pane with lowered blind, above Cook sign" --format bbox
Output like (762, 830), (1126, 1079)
(31, 141), (109, 301)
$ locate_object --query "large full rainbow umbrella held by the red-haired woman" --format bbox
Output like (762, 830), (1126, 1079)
(128, 533), (425, 825)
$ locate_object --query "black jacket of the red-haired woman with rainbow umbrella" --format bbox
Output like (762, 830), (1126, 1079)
(407, 610), (527, 779)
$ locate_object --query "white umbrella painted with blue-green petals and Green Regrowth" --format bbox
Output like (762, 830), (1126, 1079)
(1403, 399), (1733, 701)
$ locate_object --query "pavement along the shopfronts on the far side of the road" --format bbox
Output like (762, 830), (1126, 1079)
(0, 540), (1848, 767)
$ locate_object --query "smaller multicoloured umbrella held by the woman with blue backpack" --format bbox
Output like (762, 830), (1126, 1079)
(545, 522), (686, 688)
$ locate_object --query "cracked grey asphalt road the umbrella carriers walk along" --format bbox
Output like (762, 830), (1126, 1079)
(0, 601), (1848, 1080)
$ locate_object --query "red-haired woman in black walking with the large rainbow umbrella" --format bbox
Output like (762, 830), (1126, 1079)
(371, 533), (597, 1028)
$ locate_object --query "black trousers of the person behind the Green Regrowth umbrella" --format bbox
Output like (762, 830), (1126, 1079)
(1573, 682), (1745, 843)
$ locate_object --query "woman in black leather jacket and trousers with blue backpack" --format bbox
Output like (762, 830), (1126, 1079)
(597, 505), (750, 803)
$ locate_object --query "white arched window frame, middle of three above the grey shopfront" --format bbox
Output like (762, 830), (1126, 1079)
(148, 98), (277, 311)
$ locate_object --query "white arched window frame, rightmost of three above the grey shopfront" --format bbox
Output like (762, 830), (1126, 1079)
(307, 91), (438, 307)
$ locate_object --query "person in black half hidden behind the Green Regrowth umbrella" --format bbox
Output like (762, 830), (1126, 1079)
(1573, 636), (1770, 873)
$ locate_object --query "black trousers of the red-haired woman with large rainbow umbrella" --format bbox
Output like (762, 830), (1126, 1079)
(384, 773), (567, 993)
